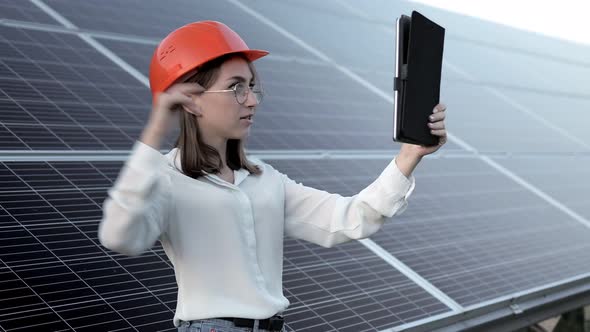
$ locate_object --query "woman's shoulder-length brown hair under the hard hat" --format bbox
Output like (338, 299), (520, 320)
(174, 54), (262, 179)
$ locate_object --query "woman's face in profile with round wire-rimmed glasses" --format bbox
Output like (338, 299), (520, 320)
(194, 57), (258, 139)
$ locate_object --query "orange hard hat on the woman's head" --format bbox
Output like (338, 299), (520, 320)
(150, 21), (268, 98)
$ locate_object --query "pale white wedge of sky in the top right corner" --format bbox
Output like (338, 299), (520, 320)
(413, 0), (590, 45)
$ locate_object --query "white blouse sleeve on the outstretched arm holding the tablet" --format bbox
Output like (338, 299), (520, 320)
(281, 158), (415, 248)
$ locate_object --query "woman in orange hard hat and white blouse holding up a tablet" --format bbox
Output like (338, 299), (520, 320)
(99, 21), (446, 331)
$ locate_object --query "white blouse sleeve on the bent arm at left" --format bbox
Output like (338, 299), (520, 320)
(98, 141), (172, 256)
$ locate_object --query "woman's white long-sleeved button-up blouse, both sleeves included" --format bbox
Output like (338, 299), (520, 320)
(98, 141), (415, 326)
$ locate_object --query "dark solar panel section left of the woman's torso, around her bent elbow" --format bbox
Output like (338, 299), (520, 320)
(0, 162), (176, 331)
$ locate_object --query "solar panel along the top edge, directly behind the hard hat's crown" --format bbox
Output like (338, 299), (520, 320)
(47, 0), (309, 57)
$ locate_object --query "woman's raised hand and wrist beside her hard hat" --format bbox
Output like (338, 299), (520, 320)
(140, 83), (205, 149)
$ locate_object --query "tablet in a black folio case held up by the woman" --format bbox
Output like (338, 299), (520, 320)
(393, 11), (445, 146)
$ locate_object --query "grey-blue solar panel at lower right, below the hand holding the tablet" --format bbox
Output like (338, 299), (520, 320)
(373, 159), (590, 306)
